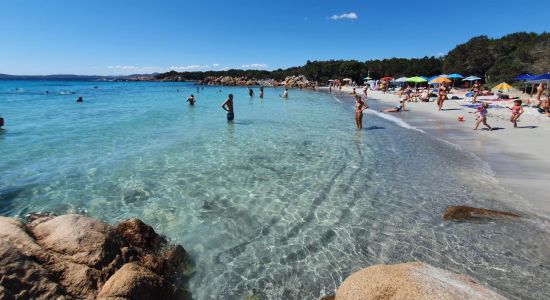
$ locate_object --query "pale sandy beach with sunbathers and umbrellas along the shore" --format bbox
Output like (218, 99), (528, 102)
(323, 87), (550, 217)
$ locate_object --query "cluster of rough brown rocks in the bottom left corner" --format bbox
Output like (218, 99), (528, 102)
(0, 214), (190, 299)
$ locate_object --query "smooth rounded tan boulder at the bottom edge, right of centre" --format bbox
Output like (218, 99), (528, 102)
(334, 263), (505, 300)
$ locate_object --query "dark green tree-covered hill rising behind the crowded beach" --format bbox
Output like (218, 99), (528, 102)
(155, 32), (550, 84)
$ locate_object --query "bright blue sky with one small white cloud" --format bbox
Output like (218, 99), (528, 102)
(0, 0), (550, 75)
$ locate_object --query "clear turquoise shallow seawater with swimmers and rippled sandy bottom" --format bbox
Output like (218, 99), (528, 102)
(0, 81), (550, 299)
